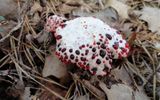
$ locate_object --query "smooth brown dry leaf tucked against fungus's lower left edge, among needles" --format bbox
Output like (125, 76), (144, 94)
(42, 46), (67, 78)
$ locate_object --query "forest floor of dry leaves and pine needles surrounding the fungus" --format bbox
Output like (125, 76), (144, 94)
(0, 0), (160, 100)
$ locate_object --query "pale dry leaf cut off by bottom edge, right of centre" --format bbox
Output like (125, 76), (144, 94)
(99, 82), (150, 100)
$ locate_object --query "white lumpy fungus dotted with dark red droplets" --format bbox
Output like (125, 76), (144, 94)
(45, 15), (129, 75)
